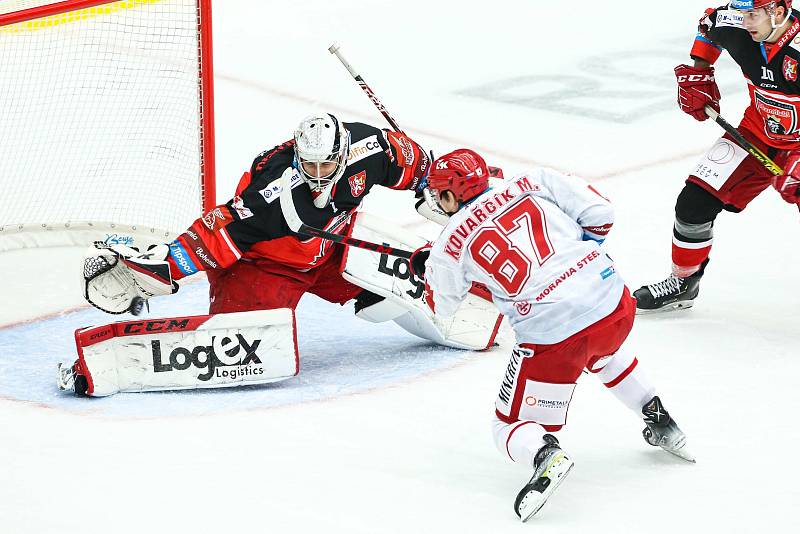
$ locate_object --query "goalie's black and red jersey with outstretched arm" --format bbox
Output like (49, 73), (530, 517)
(168, 122), (430, 279)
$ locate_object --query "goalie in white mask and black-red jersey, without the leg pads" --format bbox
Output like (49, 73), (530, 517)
(81, 113), (430, 314)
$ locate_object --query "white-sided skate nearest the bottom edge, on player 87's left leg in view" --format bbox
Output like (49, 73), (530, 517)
(514, 434), (574, 522)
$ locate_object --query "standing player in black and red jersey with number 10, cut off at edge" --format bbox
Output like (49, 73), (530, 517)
(634, 0), (800, 311)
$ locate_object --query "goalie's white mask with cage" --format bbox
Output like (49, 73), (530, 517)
(294, 113), (350, 208)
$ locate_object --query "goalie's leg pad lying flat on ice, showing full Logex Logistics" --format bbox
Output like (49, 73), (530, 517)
(58, 308), (300, 397)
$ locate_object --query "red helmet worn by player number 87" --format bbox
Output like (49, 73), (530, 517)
(428, 148), (489, 202)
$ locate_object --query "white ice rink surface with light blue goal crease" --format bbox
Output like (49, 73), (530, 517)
(0, 0), (800, 534)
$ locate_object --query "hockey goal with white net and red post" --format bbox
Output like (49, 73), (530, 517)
(0, 0), (215, 251)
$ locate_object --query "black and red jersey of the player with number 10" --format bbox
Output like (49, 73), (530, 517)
(691, 6), (800, 150)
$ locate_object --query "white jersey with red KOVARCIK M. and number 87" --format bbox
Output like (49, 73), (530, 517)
(425, 169), (625, 344)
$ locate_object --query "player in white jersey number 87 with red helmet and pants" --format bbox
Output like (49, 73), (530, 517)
(411, 149), (694, 521)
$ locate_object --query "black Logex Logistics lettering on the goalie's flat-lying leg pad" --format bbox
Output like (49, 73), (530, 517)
(150, 334), (264, 382)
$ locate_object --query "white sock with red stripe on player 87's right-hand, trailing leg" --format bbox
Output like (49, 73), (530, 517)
(590, 349), (656, 417)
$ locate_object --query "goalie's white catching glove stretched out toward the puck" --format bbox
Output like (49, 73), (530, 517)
(83, 241), (178, 315)
